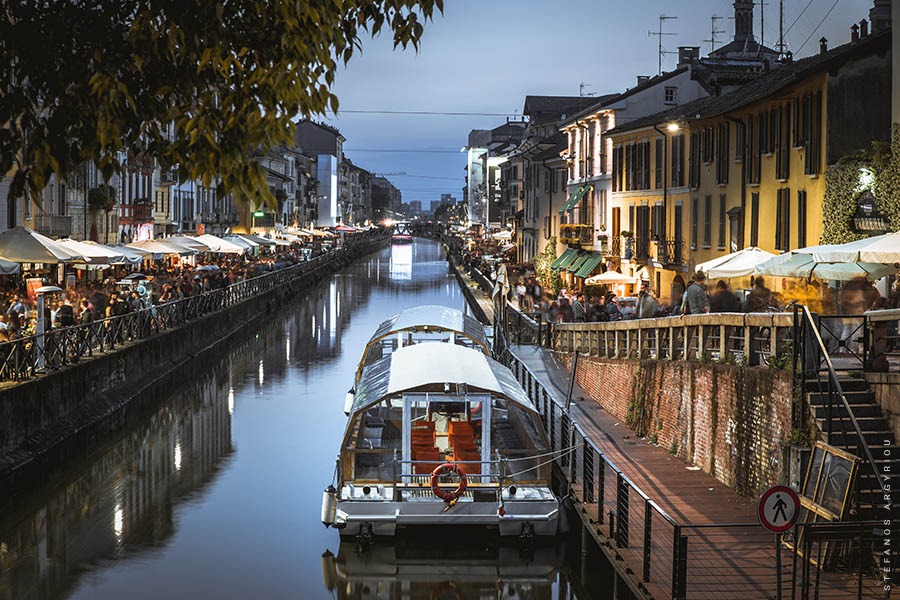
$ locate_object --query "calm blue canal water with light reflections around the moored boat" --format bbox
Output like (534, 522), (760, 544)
(0, 240), (613, 600)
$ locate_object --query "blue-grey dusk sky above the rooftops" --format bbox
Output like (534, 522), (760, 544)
(328, 0), (872, 208)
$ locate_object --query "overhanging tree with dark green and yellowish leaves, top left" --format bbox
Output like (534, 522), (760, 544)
(0, 0), (443, 202)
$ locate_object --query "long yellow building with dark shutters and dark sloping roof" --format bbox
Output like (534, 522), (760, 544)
(609, 31), (891, 302)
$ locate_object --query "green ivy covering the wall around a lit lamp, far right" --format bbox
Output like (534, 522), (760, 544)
(820, 123), (900, 244)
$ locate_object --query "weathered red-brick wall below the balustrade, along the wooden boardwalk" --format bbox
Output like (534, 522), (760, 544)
(554, 352), (791, 497)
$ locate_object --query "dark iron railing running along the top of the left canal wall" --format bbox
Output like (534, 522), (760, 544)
(0, 235), (384, 381)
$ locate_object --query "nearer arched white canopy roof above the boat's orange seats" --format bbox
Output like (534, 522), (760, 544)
(348, 343), (536, 423)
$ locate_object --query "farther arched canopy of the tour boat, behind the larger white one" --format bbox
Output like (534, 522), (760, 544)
(356, 305), (490, 377)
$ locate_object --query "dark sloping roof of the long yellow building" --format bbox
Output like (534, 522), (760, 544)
(607, 29), (891, 135)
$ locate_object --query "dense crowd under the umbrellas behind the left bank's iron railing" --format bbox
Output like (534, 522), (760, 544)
(0, 244), (334, 342)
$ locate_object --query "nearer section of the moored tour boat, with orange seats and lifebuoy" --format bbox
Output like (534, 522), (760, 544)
(322, 343), (559, 537)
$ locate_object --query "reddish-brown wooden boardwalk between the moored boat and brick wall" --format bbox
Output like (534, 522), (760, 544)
(510, 346), (888, 600)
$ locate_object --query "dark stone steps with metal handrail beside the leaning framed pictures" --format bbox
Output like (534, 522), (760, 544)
(805, 373), (900, 519)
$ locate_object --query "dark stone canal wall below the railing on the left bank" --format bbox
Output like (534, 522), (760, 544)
(0, 238), (387, 483)
